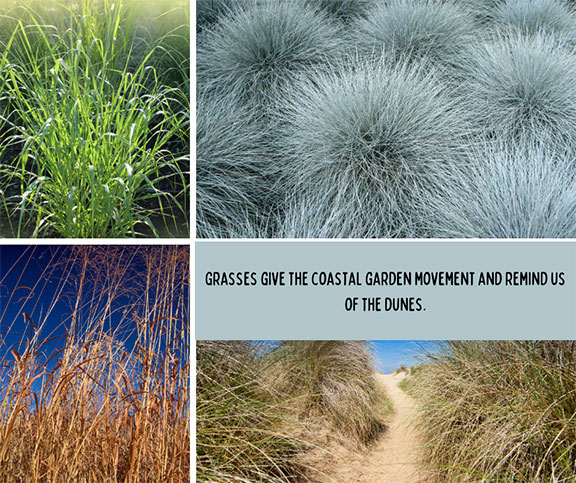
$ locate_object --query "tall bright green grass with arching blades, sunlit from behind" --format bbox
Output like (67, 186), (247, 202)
(0, 0), (189, 238)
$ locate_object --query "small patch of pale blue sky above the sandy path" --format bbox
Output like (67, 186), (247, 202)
(371, 340), (435, 374)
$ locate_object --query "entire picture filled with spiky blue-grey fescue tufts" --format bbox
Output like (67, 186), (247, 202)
(197, 0), (576, 238)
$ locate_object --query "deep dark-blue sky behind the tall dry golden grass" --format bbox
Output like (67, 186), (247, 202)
(0, 245), (182, 372)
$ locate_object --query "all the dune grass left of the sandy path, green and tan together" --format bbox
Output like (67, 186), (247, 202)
(196, 341), (386, 482)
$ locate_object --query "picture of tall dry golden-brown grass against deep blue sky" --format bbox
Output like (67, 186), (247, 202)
(0, 246), (190, 483)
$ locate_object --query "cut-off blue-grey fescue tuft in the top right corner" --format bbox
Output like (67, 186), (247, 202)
(492, 0), (576, 43)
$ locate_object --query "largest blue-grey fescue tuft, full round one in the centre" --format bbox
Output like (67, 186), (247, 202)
(278, 59), (466, 237)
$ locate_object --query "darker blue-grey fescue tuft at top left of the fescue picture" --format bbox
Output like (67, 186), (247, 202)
(197, 0), (345, 110)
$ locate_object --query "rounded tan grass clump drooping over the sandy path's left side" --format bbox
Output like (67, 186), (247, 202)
(269, 341), (385, 445)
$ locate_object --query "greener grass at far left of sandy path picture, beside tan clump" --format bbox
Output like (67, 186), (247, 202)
(196, 341), (302, 482)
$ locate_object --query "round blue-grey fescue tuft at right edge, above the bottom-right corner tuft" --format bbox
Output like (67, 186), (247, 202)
(461, 34), (576, 143)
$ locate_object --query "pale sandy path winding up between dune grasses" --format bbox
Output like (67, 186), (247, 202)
(316, 374), (430, 483)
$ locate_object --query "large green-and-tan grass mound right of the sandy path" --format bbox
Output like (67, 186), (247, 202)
(413, 341), (576, 483)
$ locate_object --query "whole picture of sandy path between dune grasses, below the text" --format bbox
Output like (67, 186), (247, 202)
(196, 340), (576, 483)
